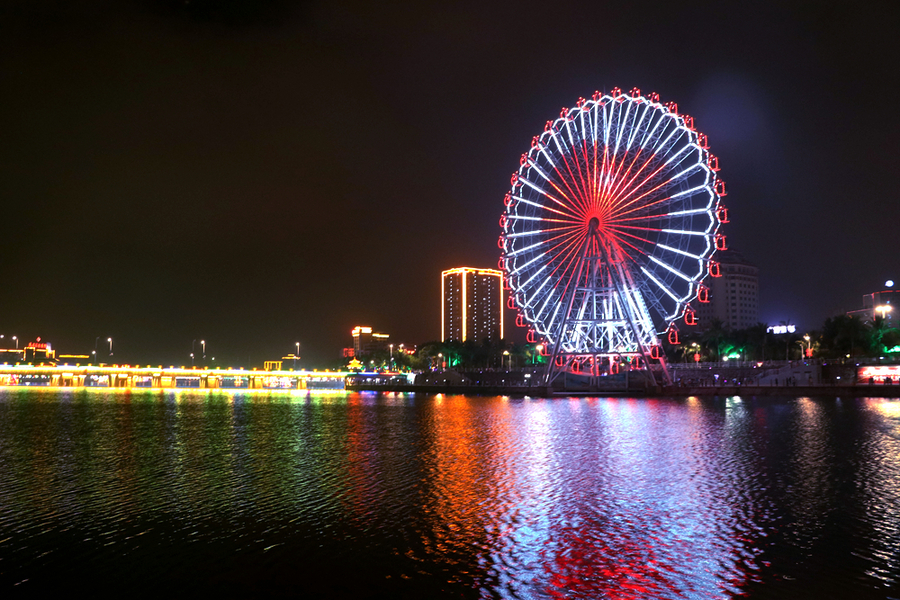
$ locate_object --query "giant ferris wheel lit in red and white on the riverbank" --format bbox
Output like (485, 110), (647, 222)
(499, 88), (728, 380)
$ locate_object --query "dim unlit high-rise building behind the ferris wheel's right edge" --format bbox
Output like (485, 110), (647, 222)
(692, 250), (759, 329)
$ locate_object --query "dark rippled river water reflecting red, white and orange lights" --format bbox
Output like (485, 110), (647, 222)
(0, 389), (900, 599)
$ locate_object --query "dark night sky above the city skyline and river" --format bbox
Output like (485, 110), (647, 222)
(0, 0), (900, 366)
